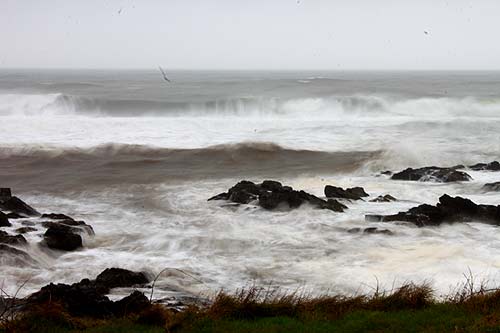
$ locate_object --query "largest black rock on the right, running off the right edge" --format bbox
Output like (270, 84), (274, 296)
(365, 194), (500, 227)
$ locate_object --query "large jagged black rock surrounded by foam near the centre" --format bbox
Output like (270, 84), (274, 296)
(208, 180), (347, 212)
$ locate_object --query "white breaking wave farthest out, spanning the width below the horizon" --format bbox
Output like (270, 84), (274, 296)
(0, 93), (500, 118)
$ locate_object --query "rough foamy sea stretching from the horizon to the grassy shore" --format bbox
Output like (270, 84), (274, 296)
(0, 70), (500, 297)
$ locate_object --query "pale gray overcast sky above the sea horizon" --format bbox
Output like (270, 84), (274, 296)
(0, 0), (500, 69)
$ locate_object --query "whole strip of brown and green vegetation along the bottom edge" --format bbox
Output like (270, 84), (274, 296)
(0, 284), (500, 333)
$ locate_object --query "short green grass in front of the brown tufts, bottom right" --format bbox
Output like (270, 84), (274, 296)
(176, 305), (500, 333)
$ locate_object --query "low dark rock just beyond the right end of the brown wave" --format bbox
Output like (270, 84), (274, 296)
(391, 166), (472, 183)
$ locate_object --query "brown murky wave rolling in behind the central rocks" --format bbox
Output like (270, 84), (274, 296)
(0, 143), (380, 192)
